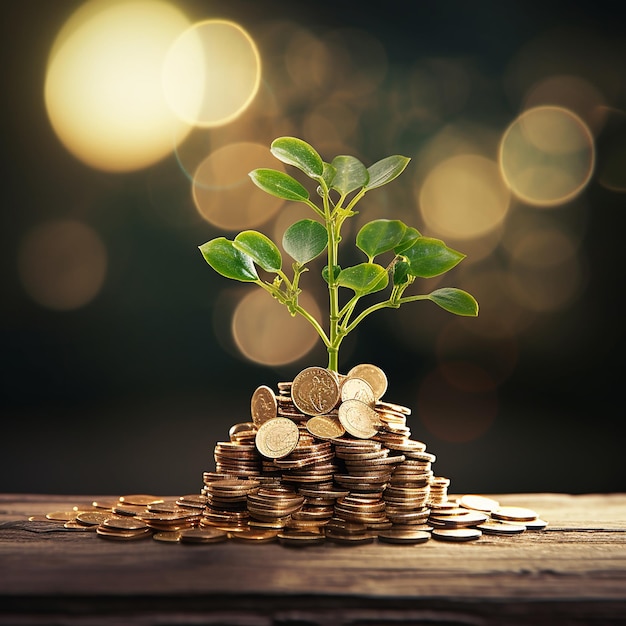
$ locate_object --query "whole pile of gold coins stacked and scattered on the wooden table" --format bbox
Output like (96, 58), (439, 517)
(37, 364), (547, 546)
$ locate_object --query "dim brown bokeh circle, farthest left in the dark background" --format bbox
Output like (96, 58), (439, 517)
(18, 220), (107, 311)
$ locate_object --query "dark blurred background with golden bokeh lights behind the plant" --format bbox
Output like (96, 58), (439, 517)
(0, 0), (626, 494)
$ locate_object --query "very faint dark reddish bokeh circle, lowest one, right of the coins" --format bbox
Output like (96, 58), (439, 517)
(417, 363), (498, 443)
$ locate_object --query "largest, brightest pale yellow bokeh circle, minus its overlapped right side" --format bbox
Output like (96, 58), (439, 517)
(44, 0), (190, 172)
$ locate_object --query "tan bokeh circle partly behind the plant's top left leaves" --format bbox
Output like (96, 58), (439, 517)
(192, 142), (284, 231)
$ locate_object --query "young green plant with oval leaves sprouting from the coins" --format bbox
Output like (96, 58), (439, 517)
(200, 137), (478, 372)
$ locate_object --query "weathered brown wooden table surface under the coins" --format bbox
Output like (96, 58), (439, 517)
(0, 493), (626, 626)
